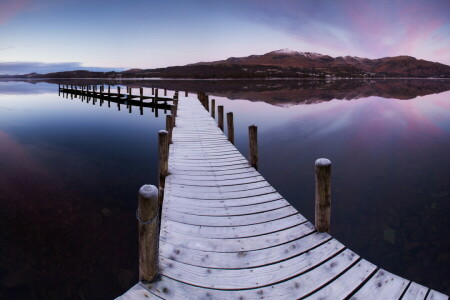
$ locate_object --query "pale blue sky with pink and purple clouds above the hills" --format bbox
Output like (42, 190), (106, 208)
(0, 0), (450, 74)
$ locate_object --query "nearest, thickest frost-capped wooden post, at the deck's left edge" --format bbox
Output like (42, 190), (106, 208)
(136, 184), (161, 282)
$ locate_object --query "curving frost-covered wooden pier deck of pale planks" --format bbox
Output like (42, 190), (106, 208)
(117, 95), (448, 300)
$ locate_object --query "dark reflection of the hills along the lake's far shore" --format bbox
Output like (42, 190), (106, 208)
(7, 79), (450, 105)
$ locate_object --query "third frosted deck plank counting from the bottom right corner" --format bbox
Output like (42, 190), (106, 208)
(350, 269), (409, 300)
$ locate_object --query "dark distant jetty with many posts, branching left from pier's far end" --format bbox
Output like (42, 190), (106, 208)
(58, 85), (178, 117)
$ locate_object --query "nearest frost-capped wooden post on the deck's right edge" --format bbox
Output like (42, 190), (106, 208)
(315, 158), (331, 233)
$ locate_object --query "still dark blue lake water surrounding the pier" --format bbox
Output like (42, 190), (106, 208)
(0, 80), (450, 299)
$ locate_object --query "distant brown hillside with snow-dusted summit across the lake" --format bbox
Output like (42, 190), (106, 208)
(3, 49), (450, 79)
